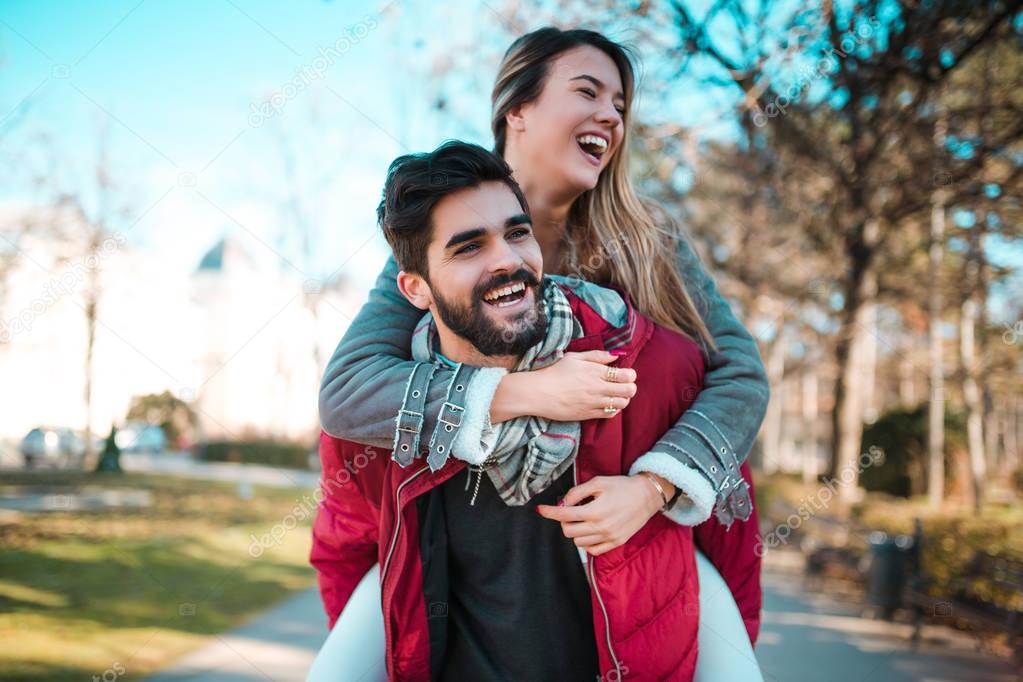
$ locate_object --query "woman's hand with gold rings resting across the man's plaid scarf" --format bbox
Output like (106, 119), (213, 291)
(490, 351), (636, 423)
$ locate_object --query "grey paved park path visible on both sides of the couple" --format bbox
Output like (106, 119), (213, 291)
(149, 569), (1017, 682)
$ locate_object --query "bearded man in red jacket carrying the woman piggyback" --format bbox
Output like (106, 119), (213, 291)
(312, 142), (757, 680)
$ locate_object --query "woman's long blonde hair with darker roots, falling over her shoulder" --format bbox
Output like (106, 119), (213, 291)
(491, 27), (715, 349)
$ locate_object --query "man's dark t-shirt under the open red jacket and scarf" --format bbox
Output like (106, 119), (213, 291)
(438, 467), (599, 682)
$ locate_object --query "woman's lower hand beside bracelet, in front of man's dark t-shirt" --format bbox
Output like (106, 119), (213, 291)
(536, 475), (675, 556)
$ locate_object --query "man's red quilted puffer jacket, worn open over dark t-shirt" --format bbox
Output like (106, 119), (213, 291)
(311, 287), (760, 680)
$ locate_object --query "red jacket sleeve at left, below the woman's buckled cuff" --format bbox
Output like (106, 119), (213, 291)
(309, 433), (379, 628)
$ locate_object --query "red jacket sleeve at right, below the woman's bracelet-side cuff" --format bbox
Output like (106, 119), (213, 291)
(693, 462), (763, 644)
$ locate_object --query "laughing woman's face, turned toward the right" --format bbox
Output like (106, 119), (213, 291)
(515, 45), (625, 195)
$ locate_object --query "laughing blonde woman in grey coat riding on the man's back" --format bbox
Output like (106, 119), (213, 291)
(314, 29), (767, 679)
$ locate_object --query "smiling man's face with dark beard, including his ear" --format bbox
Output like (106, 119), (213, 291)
(394, 182), (547, 356)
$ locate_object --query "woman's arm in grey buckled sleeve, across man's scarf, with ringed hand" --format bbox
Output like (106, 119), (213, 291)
(319, 257), (635, 468)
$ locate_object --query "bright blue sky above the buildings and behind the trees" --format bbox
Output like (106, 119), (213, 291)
(0, 0), (1023, 325)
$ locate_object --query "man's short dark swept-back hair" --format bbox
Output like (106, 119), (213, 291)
(376, 140), (529, 277)
